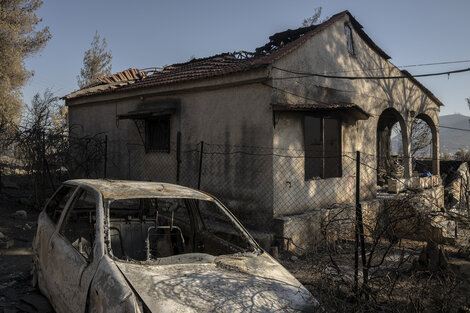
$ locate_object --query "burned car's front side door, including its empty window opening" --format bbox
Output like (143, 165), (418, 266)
(47, 187), (102, 313)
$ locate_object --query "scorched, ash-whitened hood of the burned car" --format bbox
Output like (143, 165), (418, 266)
(116, 253), (318, 312)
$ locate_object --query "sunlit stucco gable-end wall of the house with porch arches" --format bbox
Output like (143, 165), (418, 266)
(272, 16), (439, 215)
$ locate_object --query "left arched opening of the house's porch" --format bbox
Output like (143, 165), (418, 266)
(377, 108), (410, 185)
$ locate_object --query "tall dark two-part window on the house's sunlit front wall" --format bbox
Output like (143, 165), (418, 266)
(304, 116), (341, 180)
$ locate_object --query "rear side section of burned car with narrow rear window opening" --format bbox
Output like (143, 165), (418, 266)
(33, 184), (77, 293)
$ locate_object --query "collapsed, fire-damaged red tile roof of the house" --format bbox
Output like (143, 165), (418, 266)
(64, 11), (390, 100)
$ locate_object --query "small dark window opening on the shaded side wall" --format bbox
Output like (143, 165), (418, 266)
(145, 115), (170, 152)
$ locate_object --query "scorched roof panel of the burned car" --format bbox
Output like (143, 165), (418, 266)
(65, 179), (214, 200)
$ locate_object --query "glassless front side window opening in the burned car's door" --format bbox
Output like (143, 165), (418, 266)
(59, 190), (96, 260)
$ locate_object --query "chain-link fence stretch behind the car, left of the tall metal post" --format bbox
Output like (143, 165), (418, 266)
(107, 142), (366, 249)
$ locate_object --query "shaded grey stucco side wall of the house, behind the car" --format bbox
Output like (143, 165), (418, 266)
(69, 80), (273, 224)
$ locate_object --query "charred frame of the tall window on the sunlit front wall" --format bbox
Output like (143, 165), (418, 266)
(303, 114), (343, 181)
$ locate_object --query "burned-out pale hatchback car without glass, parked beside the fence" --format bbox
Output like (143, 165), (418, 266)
(33, 179), (318, 313)
